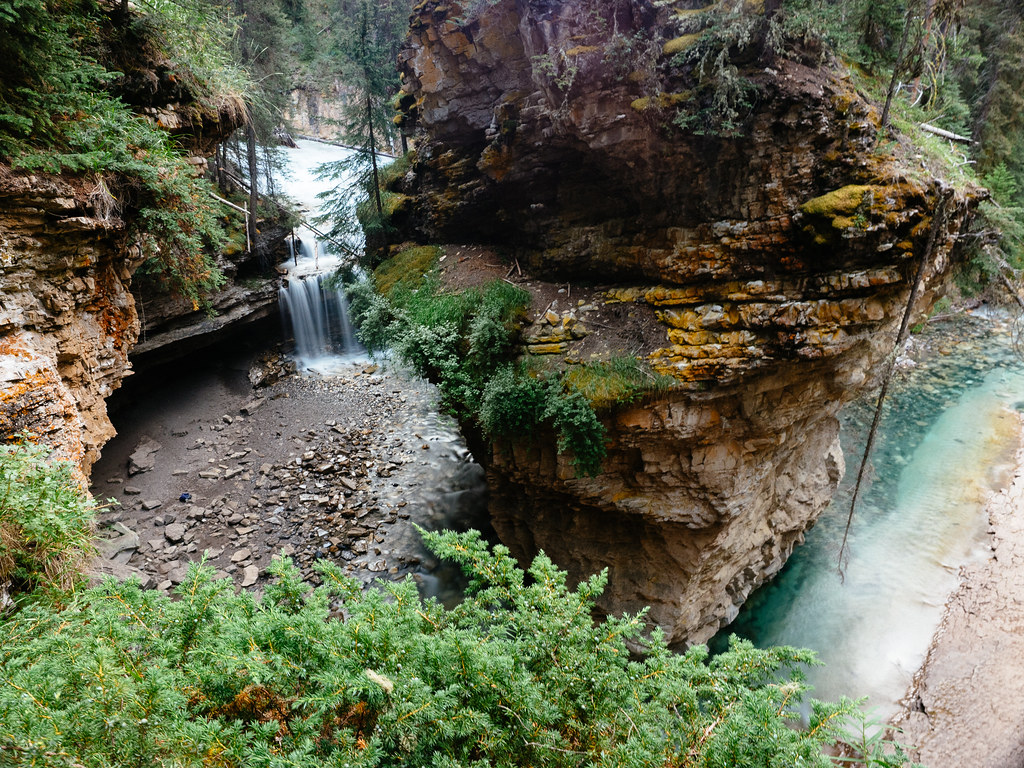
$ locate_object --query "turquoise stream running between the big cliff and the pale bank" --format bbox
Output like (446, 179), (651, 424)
(713, 313), (1024, 717)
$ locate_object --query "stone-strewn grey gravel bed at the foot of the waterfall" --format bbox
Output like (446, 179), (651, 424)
(93, 350), (485, 602)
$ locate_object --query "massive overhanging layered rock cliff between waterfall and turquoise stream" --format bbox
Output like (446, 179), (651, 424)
(393, 0), (973, 643)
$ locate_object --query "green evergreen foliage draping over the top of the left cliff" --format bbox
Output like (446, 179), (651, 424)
(0, 0), (251, 302)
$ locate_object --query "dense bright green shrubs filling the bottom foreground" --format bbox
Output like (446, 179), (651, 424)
(0, 532), (913, 768)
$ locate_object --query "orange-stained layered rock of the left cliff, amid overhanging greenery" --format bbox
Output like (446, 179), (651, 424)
(0, 43), (243, 478)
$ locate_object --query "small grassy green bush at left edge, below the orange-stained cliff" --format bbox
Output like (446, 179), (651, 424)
(0, 437), (96, 609)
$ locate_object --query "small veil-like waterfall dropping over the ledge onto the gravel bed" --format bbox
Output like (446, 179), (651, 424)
(279, 270), (364, 368)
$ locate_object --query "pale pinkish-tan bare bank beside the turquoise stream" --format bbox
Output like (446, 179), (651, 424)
(895, 421), (1024, 768)
